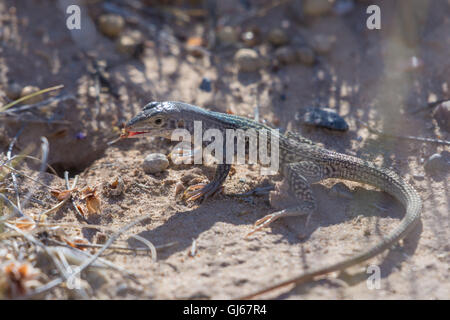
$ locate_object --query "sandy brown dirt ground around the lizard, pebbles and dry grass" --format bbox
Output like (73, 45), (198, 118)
(0, 0), (450, 299)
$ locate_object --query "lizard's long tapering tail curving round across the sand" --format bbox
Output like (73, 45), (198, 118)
(240, 153), (422, 299)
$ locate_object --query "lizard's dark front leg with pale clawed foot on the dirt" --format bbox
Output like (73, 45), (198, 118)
(183, 164), (231, 201)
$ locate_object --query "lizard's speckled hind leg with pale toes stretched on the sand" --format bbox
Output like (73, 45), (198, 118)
(246, 161), (324, 237)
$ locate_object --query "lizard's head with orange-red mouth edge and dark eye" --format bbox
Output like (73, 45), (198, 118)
(125, 101), (183, 138)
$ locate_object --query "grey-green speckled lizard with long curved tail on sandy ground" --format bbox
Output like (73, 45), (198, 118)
(123, 101), (422, 299)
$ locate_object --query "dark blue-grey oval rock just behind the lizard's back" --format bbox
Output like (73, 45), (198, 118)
(301, 107), (348, 131)
